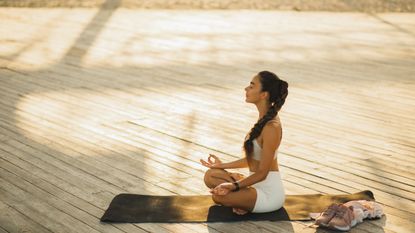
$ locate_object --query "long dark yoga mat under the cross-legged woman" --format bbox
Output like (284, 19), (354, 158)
(101, 191), (374, 223)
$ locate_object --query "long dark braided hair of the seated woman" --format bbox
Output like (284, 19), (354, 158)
(243, 71), (288, 160)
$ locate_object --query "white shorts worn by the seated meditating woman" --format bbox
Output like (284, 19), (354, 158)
(250, 171), (285, 213)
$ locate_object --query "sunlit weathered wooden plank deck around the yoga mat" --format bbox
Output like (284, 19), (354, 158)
(0, 8), (415, 233)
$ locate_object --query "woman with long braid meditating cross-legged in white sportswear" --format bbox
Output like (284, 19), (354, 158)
(200, 71), (288, 214)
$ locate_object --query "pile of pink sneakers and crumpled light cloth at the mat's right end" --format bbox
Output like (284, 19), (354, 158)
(310, 200), (383, 231)
